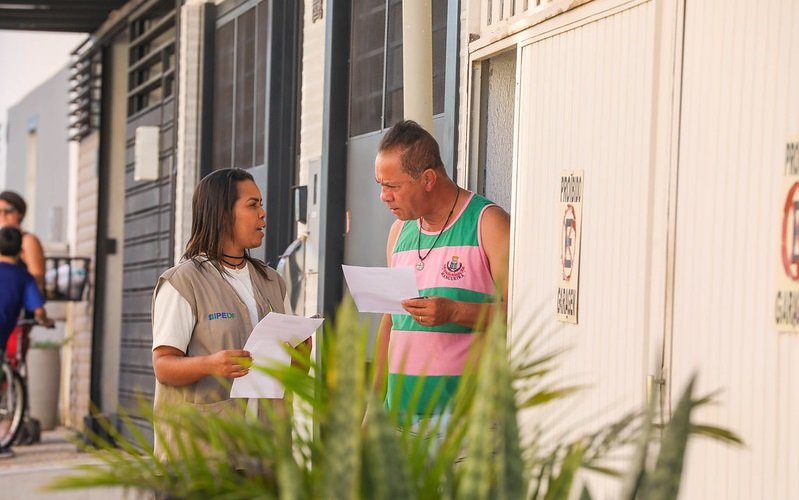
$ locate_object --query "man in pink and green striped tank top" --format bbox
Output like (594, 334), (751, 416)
(375, 121), (510, 417)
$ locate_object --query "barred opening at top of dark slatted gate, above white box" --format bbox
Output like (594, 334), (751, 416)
(128, 2), (176, 116)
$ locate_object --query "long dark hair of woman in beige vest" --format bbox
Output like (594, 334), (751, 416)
(183, 168), (267, 276)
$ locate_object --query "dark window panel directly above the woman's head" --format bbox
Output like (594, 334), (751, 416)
(213, 2), (268, 169)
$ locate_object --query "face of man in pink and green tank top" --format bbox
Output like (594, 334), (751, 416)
(375, 150), (425, 220)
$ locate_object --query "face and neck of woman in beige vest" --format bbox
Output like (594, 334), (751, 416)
(223, 180), (266, 255)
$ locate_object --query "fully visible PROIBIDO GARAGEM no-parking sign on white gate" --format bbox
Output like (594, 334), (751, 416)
(556, 170), (583, 324)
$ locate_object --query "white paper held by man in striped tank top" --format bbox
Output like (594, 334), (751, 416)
(341, 266), (419, 314)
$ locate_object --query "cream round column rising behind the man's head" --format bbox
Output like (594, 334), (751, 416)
(402, 0), (433, 132)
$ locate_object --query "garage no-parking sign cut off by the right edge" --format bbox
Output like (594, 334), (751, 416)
(774, 137), (799, 333)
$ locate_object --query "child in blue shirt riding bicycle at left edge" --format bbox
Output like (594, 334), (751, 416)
(0, 226), (53, 458)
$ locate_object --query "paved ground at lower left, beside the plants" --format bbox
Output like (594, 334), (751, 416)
(0, 429), (136, 500)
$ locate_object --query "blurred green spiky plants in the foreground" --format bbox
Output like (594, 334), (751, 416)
(51, 303), (740, 500)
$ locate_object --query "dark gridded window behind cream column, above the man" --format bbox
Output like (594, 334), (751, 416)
(350, 0), (447, 136)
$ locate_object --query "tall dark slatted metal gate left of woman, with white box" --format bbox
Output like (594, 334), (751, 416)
(119, 1), (177, 440)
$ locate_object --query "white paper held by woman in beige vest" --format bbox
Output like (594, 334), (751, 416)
(230, 312), (324, 399)
